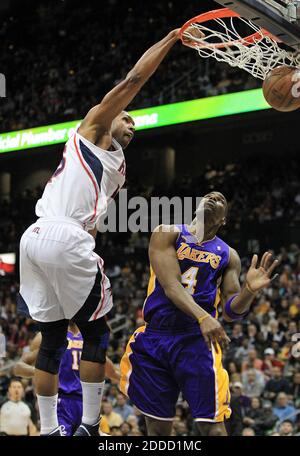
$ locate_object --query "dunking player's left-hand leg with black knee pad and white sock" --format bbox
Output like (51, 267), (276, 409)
(34, 320), (68, 434)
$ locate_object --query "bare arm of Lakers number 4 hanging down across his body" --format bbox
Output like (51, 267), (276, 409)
(149, 225), (230, 352)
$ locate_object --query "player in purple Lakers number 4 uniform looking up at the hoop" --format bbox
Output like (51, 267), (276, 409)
(120, 192), (277, 436)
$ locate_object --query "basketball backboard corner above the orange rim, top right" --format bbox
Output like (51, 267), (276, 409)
(215, 0), (300, 51)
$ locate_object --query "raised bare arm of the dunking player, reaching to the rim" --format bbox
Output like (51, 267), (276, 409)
(79, 29), (180, 142)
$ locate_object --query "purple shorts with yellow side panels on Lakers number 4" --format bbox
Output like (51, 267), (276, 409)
(120, 326), (231, 423)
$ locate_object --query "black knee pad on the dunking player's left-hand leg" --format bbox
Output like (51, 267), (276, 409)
(35, 322), (68, 375)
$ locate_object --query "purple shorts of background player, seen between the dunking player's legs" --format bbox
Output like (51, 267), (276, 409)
(57, 395), (82, 435)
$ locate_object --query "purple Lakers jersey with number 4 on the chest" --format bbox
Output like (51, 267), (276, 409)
(144, 225), (229, 329)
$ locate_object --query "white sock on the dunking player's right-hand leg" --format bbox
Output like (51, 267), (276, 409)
(81, 381), (105, 424)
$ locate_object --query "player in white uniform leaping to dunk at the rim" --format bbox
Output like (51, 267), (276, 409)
(19, 30), (198, 435)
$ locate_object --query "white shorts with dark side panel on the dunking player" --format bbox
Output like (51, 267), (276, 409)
(18, 217), (113, 322)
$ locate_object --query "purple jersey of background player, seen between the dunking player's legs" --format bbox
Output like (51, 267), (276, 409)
(58, 331), (83, 396)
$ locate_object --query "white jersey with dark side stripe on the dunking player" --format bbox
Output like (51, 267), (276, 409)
(36, 133), (126, 230)
